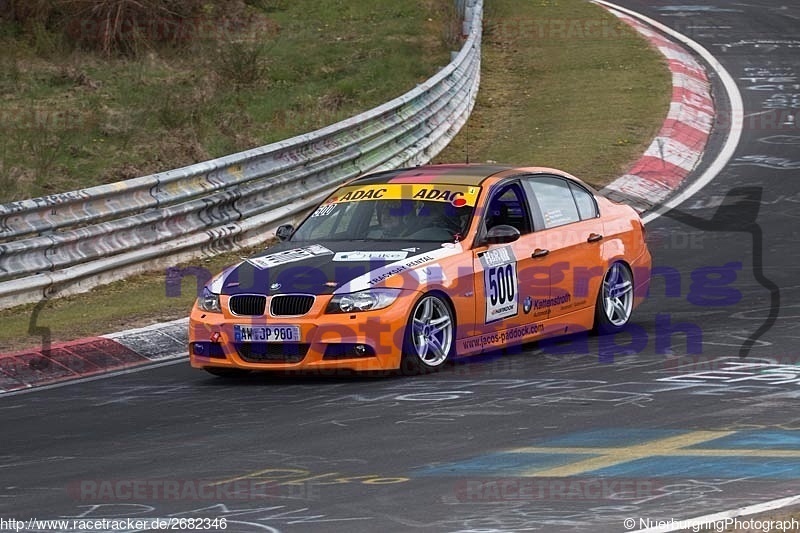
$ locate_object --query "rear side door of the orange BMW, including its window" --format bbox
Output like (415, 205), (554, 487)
(521, 175), (603, 330)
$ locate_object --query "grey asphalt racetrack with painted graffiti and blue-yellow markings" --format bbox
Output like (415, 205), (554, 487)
(0, 0), (800, 533)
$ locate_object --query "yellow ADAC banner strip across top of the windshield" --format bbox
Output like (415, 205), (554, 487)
(318, 183), (481, 207)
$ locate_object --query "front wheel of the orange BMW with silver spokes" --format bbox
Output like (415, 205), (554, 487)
(400, 294), (456, 375)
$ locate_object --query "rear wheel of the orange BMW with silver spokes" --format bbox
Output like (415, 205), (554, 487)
(594, 261), (633, 335)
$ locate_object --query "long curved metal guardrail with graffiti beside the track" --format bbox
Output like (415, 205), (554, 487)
(0, 0), (483, 308)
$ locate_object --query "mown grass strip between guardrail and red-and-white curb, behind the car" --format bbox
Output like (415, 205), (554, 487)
(436, 0), (672, 187)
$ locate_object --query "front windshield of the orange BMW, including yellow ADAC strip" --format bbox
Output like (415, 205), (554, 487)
(292, 183), (480, 242)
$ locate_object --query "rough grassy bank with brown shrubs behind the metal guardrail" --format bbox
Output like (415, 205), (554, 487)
(0, 0), (459, 202)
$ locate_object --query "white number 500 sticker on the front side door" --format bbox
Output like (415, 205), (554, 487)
(480, 246), (519, 324)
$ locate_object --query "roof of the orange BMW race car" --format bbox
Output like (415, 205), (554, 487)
(348, 164), (582, 190)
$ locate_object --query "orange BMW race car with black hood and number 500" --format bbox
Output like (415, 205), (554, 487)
(189, 165), (651, 375)
